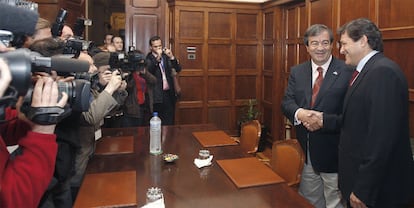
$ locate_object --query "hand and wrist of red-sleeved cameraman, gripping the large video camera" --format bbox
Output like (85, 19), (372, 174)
(31, 77), (68, 134)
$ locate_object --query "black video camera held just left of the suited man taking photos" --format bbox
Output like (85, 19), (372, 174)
(109, 50), (146, 71)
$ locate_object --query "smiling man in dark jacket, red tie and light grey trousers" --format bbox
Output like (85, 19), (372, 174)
(282, 24), (352, 208)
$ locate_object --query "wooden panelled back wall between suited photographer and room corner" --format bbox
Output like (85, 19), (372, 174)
(169, 1), (261, 133)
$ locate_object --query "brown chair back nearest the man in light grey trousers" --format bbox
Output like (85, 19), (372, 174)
(270, 139), (305, 186)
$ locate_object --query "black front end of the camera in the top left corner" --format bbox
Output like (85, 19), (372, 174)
(0, 3), (39, 36)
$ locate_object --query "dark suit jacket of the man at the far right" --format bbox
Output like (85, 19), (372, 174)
(339, 53), (414, 207)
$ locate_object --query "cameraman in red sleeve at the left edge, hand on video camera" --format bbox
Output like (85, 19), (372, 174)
(0, 56), (68, 207)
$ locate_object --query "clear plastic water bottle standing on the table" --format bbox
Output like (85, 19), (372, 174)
(150, 112), (162, 155)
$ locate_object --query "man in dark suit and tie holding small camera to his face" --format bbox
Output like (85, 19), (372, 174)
(147, 36), (181, 125)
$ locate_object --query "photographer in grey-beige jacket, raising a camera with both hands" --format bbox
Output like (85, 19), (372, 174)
(71, 52), (125, 199)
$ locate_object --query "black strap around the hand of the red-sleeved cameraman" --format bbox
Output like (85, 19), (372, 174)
(26, 106), (72, 125)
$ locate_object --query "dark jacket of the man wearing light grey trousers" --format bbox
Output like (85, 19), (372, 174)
(282, 58), (352, 173)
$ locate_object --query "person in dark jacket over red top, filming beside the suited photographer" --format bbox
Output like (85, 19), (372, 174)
(122, 50), (157, 127)
